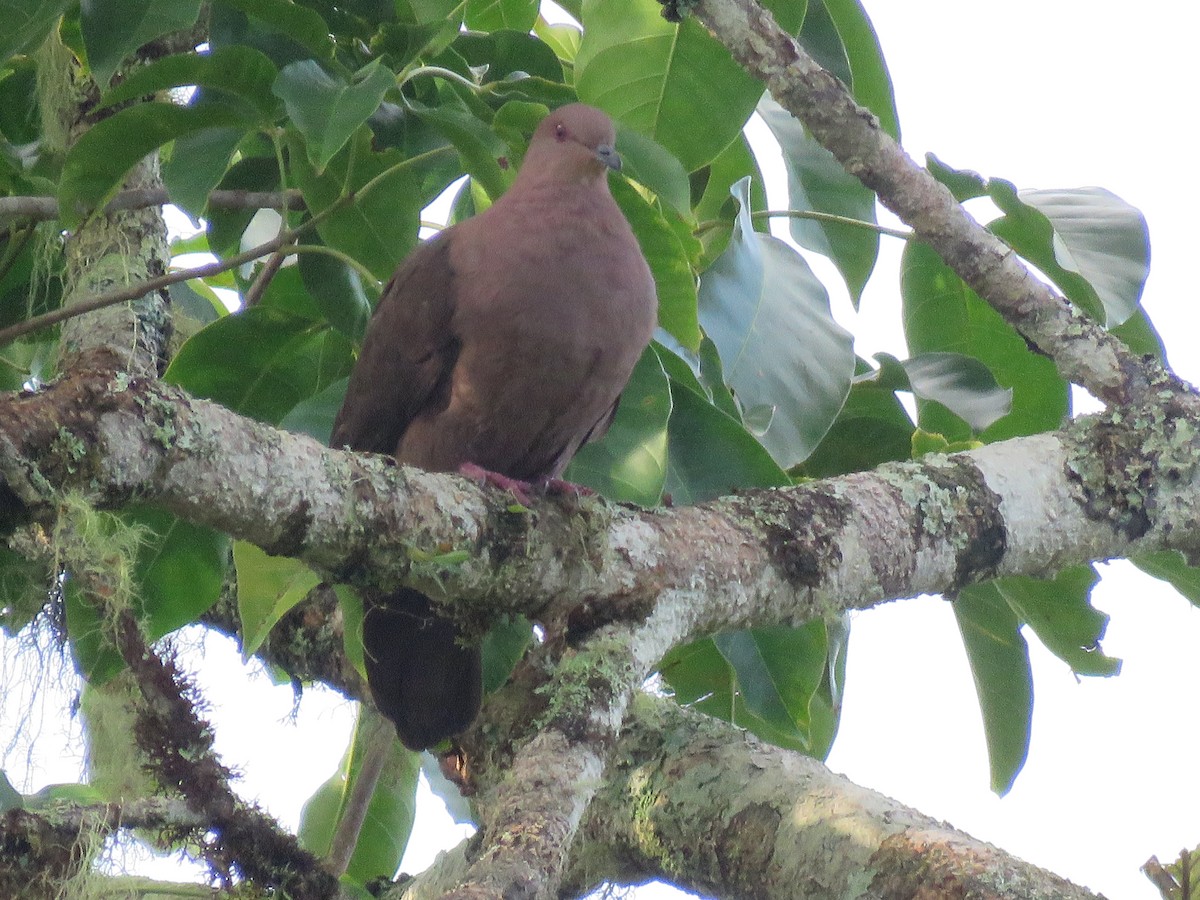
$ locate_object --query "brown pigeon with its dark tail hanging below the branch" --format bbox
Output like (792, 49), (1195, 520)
(330, 103), (656, 749)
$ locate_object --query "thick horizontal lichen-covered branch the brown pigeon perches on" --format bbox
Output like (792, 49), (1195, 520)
(0, 372), (1200, 655)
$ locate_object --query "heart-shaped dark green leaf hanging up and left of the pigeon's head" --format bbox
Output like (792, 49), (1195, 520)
(274, 60), (396, 175)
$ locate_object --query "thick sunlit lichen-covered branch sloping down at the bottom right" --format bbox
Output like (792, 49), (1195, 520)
(563, 696), (1096, 900)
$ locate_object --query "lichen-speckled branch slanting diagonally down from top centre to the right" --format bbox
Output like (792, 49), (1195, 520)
(680, 0), (1164, 404)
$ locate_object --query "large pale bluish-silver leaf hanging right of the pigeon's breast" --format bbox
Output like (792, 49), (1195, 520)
(700, 179), (854, 468)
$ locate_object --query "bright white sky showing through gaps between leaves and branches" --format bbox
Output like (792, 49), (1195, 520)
(0, 0), (1200, 900)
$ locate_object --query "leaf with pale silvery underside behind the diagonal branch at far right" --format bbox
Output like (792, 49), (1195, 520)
(988, 179), (1150, 326)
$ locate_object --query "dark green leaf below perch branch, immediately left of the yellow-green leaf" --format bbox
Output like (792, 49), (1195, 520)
(120, 506), (229, 641)
